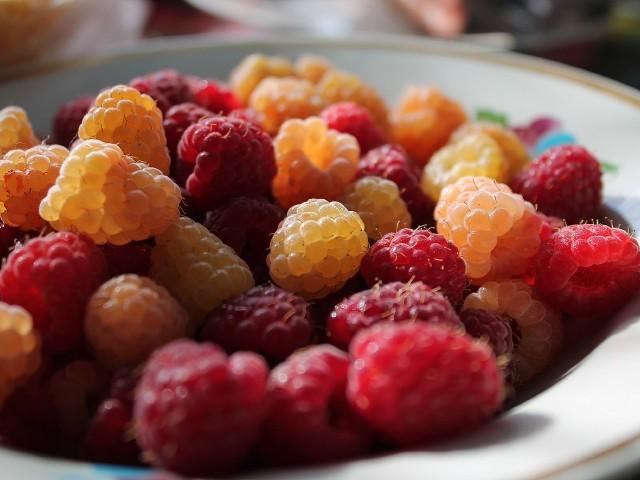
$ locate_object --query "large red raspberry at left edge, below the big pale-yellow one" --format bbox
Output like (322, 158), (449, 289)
(0, 232), (106, 352)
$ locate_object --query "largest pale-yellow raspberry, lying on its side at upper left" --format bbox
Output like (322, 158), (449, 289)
(40, 140), (182, 245)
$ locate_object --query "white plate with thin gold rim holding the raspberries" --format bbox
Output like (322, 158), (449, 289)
(0, 36), (640, 480)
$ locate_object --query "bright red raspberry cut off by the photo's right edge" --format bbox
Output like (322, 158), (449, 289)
(535, 224), (640, 316)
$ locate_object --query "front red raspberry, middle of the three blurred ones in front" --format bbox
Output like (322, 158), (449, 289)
(260, 345), (371, 464)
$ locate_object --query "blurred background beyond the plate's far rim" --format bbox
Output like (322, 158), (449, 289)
(0, 0), (640, 88)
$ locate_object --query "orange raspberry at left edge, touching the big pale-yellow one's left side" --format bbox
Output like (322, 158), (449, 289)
(0, 145), (69, 230)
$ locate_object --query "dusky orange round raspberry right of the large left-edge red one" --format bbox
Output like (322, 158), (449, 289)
(84, 274), (189, 369)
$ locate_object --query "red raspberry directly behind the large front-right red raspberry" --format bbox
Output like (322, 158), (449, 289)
(327, 282), (464, 348)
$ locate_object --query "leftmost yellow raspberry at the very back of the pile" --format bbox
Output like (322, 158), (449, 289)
(229, 53), (296, 105)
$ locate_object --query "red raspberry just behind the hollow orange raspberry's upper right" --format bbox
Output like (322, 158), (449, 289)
(320, 102), (384, 155)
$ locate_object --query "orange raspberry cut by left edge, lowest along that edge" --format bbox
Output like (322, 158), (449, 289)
(0, 302), (40, 405)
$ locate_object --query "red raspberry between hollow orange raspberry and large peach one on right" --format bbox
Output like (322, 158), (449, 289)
(357, 145), (434, 225)
